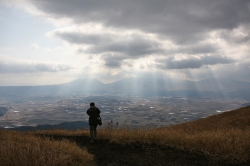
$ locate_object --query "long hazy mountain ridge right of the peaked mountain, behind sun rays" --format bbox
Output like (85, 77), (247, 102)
(107, 78), (250, 95)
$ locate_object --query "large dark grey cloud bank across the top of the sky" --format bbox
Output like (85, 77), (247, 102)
(31, 0), (250, 44)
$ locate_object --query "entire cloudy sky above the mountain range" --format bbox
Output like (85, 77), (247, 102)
(0, 0), (250, 86)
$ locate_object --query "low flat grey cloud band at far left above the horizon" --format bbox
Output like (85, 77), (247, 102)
(0, 62), (72, 73)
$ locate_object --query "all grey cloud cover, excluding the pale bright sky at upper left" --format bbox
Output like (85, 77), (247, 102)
(0, 0), (250, 85)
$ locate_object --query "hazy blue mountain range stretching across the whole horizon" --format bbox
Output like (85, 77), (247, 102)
(0, 77), (250, 100)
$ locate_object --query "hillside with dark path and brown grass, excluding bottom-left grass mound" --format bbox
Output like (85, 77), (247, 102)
(0, 106), (250, 166)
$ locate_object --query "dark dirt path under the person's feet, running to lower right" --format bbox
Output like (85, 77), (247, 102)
(51, 137), (249, 166)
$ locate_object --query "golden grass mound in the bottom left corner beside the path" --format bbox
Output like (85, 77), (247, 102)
(0, 130), (93, 166)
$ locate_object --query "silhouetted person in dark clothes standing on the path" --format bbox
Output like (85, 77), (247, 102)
(87, 102), (101, 143)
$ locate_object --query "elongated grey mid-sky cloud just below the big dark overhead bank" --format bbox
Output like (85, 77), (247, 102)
(53, 31), (163, 58)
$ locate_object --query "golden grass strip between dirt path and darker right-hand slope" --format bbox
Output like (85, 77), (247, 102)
(95, 128), (250, 161)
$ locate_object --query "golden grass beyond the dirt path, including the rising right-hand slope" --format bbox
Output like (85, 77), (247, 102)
(30, 107), (250, 161)
